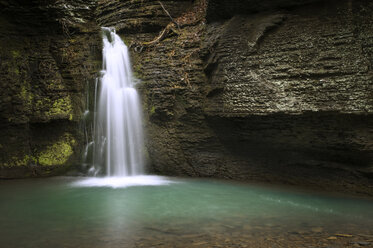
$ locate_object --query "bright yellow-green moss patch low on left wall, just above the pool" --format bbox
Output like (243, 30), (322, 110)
(37, 134), (76, 166)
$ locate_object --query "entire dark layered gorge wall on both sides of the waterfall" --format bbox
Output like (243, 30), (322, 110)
(0, 0), (373, 195)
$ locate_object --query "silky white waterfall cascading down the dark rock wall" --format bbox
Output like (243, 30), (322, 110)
(93, 28), (144, 177)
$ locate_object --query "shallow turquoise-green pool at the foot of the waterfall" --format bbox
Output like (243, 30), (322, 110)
(0, 177), (373, 248)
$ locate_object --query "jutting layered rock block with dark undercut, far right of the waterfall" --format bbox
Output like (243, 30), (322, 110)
(204, 1), (373, 195)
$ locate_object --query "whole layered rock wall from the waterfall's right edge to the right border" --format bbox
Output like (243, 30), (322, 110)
(98, 0), (373, 195)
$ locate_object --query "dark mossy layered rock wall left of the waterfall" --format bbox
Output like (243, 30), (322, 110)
(0, 0), (101, 178)
